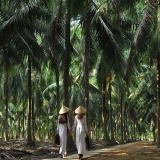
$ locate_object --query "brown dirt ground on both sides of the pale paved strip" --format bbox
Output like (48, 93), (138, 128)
(0, 140), (160, 160)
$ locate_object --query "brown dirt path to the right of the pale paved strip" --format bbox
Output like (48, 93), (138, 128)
(84, 141), (160, 160)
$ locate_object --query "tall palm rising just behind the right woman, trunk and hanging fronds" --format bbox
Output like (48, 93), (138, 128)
(80, 1), (97, 130)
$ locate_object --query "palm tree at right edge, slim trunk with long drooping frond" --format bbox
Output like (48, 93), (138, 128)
(126, 0), (160, 146)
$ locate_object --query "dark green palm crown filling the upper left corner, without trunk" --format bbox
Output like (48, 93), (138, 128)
(0, 1), (50, 67)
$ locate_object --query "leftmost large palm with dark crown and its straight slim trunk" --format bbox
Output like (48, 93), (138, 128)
(0, 1), (48, 145)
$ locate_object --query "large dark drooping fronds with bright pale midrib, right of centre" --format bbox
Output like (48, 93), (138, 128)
(92, 2), (128, 86)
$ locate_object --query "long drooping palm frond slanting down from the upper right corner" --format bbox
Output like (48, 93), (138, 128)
(126, 0), (158, 83)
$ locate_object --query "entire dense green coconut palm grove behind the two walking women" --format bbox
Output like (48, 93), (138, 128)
(0, 0), (160, 150)
